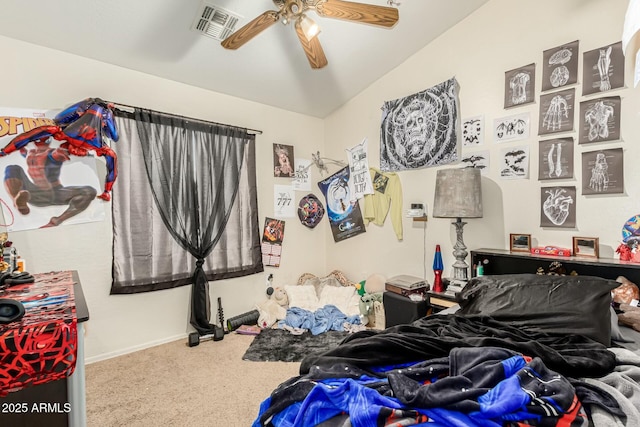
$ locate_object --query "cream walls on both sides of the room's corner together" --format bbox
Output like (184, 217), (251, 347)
(0, 0), (640, 362)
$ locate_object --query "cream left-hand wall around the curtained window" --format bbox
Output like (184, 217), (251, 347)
(0, 37), (328, 362)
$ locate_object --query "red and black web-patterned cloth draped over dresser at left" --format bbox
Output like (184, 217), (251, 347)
(0, 271), (78, 397)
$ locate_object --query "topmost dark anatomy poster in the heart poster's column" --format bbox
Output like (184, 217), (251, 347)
(542, 40), (579, 92)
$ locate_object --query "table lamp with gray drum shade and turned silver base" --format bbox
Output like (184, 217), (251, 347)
(433, 168), (482, 282)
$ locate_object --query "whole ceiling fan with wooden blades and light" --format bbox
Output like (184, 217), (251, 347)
(222, 0), (398, 69)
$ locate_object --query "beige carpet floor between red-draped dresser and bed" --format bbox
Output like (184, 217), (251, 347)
(86, 333), (300, 427)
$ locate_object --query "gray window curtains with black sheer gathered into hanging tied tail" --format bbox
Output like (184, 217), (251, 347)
(111, 109), (264, 334)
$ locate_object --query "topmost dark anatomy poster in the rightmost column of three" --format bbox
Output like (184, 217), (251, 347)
(582, 42), (624, 95)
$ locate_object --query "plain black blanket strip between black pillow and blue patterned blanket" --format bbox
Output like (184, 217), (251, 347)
(300, 314), (615, 377)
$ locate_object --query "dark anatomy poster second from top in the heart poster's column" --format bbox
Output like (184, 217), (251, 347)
(538, 88), (576, 135)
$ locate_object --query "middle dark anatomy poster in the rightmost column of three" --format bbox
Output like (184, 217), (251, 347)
(578, 96), (621, 144)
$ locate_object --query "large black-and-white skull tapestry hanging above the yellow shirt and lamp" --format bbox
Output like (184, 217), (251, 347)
(380, 78), (460, 171)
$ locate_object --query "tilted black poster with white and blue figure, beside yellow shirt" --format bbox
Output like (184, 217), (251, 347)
(318, 167), (366, 242)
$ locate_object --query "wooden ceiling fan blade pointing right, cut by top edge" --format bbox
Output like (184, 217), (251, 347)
(315, 0), (399, 27)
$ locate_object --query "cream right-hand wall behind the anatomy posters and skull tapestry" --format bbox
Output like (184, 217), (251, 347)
(325, 0), (640, 281)
